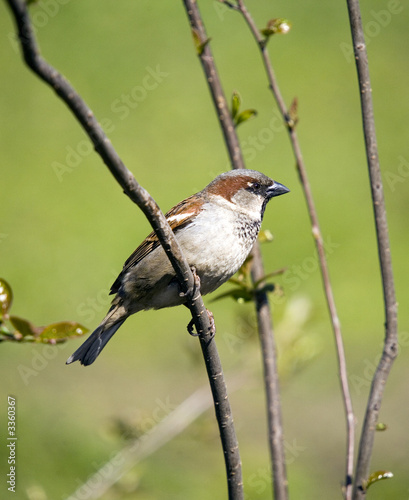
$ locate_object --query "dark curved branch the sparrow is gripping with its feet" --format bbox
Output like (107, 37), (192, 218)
(6, 0), (242, 498)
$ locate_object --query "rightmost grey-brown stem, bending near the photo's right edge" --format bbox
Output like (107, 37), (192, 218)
(347, 0), (398, 500)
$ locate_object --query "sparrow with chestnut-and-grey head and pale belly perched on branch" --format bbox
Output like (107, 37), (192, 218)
(66, 169), (290, 366)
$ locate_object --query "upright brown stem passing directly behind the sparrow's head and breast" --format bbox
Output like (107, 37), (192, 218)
(183, 0), (288, 500)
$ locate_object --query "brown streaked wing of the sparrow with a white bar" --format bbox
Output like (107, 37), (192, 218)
(110, 195), (203, 294)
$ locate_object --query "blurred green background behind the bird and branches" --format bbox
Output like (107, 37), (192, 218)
(0, 0), (409, 500)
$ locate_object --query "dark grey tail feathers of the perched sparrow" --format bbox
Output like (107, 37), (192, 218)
(66, 306), (128, 366)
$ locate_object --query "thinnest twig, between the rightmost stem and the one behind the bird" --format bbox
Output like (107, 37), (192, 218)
(231, 0), (355, 499)
